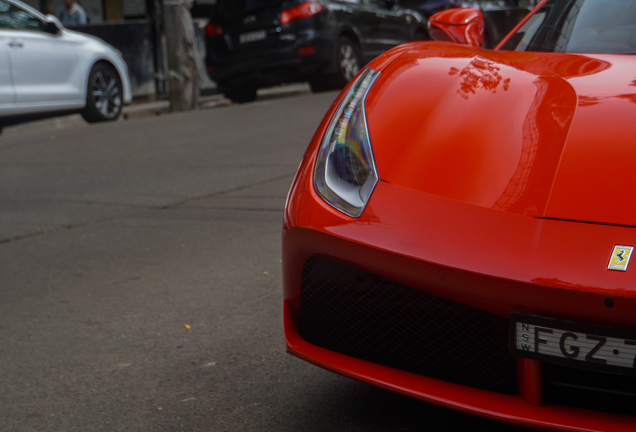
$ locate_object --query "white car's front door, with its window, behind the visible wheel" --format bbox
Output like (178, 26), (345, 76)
(0, 0), (86, 106)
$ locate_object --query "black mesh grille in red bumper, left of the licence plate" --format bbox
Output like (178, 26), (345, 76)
(300, 258), (517, 394)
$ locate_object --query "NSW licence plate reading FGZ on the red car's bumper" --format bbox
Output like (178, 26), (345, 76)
(510, 312), (636, 375)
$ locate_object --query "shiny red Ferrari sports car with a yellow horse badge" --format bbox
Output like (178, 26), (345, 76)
(283, 0), (636, 431)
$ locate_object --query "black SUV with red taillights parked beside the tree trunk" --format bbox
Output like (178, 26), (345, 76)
(206, 0), (428, 102)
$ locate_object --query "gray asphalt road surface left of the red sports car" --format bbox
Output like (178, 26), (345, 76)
(0, 93), (532, 431)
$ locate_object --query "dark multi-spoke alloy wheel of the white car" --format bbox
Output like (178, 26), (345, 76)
(82, 63), (123, 123)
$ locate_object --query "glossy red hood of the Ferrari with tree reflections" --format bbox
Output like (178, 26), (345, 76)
(367, 42), (636, 226)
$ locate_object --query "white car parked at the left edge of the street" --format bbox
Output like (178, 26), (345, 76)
(0, 0), (132, 130)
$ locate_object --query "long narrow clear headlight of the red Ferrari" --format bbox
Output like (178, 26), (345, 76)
(314, 69), (380, 217)
